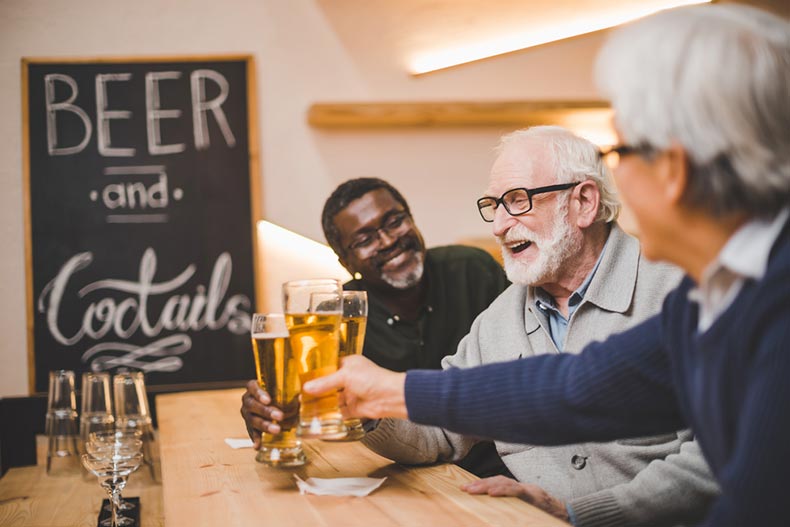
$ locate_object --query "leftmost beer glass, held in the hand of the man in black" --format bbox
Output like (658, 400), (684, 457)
(250, 313), (306, 467)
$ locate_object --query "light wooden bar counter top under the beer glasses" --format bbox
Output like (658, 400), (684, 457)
(156, 390), (566, 527)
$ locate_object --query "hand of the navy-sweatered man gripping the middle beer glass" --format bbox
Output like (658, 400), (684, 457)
(302, 355), (408, 419)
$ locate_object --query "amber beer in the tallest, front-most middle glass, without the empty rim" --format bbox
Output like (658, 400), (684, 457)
(285, 312), (346, 439)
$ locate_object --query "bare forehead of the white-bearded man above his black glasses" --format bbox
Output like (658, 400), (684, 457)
(485, 142), (556, 196)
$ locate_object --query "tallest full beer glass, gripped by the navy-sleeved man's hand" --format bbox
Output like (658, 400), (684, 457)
(283, 279), (346, 438)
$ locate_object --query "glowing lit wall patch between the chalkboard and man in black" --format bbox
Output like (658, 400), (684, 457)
(256, 221), (351, 312)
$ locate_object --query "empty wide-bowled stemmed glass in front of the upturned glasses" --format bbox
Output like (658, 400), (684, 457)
(82, 448), (143, 527)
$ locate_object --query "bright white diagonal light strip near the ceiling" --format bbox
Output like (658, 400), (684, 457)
(409, 0), (710, 75)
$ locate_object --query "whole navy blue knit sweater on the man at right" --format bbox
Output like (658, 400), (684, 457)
(406, 221), (790, 527)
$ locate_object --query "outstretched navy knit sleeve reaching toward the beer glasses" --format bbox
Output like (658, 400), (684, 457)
(406, 316), (684, 444)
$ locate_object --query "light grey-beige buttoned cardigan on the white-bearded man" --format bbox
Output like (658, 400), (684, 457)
(364, 224), (717, 526)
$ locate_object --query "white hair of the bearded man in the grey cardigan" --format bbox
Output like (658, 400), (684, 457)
(496, 126), (620, 223)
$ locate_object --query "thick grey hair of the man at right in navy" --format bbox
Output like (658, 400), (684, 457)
(595, 4), (790, 217)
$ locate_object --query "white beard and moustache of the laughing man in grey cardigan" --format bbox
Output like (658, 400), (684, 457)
(497, 201), (582, 285)
